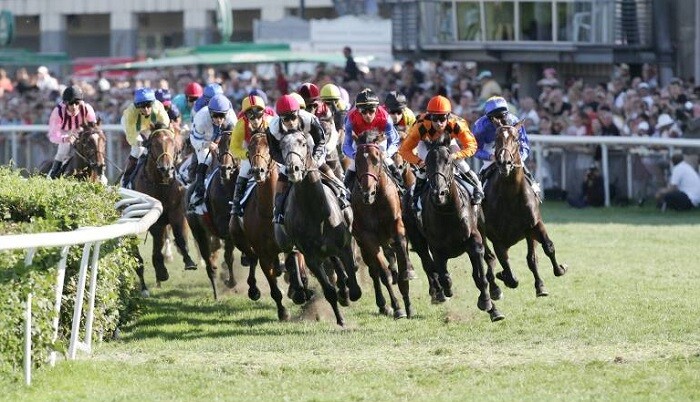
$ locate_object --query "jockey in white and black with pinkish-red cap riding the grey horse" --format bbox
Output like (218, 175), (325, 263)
(267, 95), (346, 224)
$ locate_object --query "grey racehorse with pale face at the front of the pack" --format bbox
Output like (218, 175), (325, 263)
(276, 131), (362, 326)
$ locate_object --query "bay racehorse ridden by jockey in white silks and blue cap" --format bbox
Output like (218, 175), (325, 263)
(187, 131), (238, 300)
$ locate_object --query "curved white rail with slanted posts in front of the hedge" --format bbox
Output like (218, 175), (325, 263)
(0, 189), (163, 385)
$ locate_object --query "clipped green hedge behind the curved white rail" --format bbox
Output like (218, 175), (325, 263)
(0, 167), (138, 378)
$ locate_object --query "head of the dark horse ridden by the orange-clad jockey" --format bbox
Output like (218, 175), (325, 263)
(425, 142), (454, 205)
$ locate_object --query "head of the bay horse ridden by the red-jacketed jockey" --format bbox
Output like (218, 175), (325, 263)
(355, 130), (384, 205)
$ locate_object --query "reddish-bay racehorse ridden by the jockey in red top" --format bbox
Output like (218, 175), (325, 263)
(351, 131), (414, 318)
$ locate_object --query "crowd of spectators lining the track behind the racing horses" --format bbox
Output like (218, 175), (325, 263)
(0, 60), (700, 204)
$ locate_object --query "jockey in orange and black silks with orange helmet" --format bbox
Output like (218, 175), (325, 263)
(399, 95), (484, 207)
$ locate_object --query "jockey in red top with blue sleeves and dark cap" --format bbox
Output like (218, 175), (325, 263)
(343, 88), (403, 191)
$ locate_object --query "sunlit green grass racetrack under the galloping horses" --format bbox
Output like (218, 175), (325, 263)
(0, 202), (700, 401)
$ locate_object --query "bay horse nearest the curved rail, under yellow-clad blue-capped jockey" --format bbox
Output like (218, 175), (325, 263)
(133, 125), (197, 290)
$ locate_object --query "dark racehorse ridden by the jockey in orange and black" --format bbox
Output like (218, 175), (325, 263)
(403, 136), (504, 321)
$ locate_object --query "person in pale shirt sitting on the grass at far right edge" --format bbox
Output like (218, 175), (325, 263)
(656, 154), (700, 211)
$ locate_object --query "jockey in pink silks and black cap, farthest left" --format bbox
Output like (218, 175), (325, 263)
(48, 86), (97, 179)
